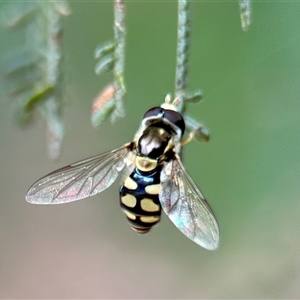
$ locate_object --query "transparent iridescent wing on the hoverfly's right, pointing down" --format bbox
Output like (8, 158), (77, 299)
(159, 157), (219, 250)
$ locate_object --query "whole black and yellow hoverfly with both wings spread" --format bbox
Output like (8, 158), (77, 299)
(26, 97), (219, 250)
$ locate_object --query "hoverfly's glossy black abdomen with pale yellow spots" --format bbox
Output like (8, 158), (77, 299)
(120, 168), (161, 233)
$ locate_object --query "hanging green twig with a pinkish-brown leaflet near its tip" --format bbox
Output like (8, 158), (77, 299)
(91, 0), (126, 127)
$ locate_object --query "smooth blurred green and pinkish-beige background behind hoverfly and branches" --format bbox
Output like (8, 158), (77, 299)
(0, 1), (300, 299)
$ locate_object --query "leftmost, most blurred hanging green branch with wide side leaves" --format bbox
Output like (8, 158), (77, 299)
(2, 1), (70, 159)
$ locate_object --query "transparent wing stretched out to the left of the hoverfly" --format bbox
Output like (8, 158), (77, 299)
(26, 144), (131, 204)
